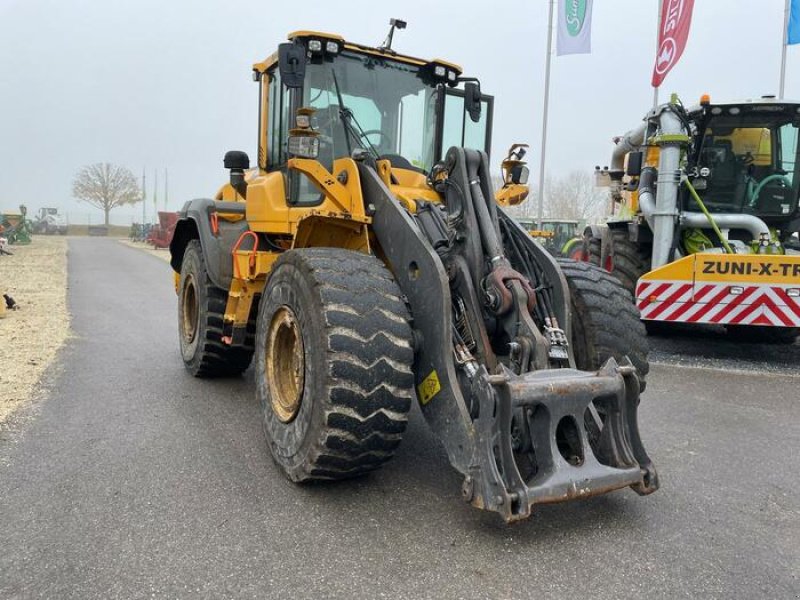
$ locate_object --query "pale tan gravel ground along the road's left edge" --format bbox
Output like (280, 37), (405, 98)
(0, 236), (69, 423)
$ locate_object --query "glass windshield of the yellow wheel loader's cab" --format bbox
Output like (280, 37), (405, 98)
(302, 52), (436, 173)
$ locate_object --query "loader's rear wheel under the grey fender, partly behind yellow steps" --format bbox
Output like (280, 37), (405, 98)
(178, 240), (255, 377)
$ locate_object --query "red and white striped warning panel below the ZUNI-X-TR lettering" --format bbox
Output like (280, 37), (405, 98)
(636, 279), (800, 327)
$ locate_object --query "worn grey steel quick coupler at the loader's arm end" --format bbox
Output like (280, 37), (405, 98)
(462, 359), (658, 521)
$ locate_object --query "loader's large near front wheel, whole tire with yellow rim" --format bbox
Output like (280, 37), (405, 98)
(255, 248), (414, 482)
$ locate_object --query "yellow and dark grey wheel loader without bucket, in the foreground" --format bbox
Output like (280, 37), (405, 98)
(170, 23), (658, 521)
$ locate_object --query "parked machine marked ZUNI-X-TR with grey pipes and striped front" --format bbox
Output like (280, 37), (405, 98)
(586, 96), (800, 343)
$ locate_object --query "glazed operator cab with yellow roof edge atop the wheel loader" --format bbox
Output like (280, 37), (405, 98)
(254, 31), (493, 206)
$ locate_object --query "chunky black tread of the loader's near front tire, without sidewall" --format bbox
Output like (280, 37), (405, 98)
(262, 248), (414, 481)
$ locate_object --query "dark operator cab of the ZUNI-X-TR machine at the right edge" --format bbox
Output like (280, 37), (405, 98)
(684, 99), (800, 225)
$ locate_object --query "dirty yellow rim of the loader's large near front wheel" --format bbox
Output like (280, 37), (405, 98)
(265, 306), (305, 423)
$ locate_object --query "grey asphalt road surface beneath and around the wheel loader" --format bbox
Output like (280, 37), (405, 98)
(0, 239), (800, 599)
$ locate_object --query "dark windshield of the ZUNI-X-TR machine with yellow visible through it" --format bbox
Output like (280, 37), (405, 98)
(690, 107), (800, 216)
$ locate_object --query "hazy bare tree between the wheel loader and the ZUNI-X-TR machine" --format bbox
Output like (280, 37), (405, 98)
(544, 171), (608, 221)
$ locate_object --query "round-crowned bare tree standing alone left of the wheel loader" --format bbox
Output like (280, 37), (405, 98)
(72, 163), (142, 225)
